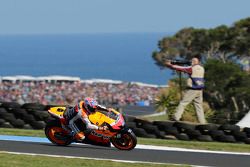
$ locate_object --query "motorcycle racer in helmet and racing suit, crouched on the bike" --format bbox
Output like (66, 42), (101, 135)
(60, 97), (111, 140)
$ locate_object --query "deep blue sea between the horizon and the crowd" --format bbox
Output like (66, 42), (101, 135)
(0, 33), (171, 85)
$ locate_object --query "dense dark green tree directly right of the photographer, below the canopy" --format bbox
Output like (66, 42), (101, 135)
(204, 59), (250, 121)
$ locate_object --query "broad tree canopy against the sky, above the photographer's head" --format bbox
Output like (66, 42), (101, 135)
(152, 18), (250, 67)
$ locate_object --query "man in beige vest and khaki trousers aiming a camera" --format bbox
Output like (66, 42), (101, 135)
(165, 55), (206, 124)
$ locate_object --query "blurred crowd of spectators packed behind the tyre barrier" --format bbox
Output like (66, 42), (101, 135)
(0, 81), (160, 106)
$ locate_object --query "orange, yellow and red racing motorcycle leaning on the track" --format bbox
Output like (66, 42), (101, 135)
(45, 106), (137, 150)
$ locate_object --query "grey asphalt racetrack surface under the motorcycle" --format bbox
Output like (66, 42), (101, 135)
(0, 140), (250, 167)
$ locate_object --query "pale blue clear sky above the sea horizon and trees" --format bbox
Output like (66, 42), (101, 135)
(0, 0), (250, 35)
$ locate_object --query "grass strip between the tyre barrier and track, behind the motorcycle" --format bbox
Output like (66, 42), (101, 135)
(0, 128), (250, 152)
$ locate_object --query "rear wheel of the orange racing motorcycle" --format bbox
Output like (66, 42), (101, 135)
(45, 120), (73, 146)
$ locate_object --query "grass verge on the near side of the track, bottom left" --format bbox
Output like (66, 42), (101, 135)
(0, 152), (187, 167)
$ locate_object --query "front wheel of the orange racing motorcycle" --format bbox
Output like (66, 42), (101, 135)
(111, 131), (137, 150)
